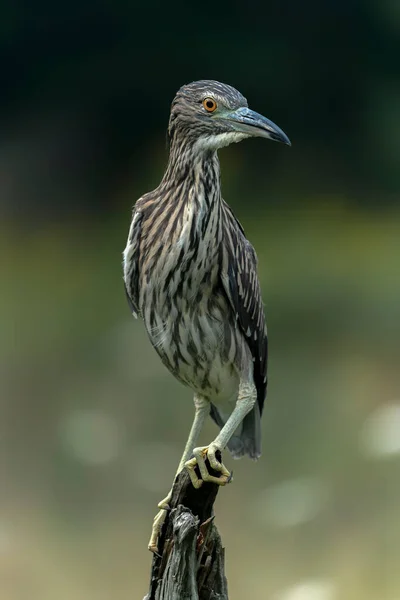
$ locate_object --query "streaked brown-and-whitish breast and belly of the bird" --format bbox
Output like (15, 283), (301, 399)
(136, 199), (237, 397)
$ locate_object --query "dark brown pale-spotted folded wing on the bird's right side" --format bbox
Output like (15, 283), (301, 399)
(221, 203), (268, 414)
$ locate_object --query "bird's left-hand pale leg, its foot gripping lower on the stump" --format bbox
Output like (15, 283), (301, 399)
(148, 395), (210, 553)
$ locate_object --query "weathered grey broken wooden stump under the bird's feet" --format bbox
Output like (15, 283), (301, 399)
(144, 463), (228, 600)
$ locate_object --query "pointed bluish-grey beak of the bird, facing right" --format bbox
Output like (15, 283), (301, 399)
(222, 106), (291, 146)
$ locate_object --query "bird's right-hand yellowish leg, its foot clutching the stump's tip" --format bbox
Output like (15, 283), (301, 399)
(185, 380), (257, 488)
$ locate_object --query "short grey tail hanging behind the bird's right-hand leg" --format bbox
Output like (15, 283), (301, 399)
(210, 403), (261, 460)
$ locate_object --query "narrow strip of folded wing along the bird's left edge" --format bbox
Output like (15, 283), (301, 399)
(123, 208), (142, 317)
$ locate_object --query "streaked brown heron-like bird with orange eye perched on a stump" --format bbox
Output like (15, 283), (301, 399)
(123, 80), (291, 553)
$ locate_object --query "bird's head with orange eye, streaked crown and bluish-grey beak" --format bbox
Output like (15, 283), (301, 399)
(168, 80), (290, 150)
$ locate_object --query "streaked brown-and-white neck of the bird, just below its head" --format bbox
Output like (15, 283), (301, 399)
(161, 141), (221, 206)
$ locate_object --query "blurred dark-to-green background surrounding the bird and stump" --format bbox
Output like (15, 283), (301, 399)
(0, 0), (400, 600)
